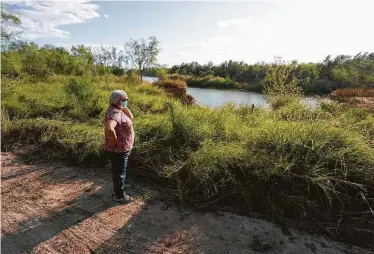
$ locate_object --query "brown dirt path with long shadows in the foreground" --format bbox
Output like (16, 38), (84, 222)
(1, 153), (368, 254)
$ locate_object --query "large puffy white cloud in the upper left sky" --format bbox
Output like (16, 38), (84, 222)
(7, 0), (100, 40)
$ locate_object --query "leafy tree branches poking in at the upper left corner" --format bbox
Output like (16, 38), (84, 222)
(0, 4), (21, 43)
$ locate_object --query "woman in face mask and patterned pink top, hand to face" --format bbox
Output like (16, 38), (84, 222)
(104, 90), (134, 202)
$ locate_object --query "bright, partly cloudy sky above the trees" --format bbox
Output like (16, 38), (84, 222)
(2, 0), (374, 66)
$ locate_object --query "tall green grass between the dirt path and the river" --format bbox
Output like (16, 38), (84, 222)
(1, 77), (374, 226)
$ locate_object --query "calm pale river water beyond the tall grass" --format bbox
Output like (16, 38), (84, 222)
(143, 77), (318, 107)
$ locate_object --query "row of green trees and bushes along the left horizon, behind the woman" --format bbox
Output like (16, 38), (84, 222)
(1, 37), (159, 81)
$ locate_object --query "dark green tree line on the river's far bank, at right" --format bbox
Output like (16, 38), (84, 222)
(168, 53), (374, 94)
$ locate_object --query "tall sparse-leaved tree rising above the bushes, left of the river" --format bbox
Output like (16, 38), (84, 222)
(125, 36), (160, 82)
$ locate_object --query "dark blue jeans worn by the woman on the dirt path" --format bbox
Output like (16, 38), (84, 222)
(107, 152), (130, 198)
